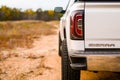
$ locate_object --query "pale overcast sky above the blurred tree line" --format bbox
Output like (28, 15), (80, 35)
(0, 0), (68, 10)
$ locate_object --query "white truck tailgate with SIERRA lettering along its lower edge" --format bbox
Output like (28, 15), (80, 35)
(85, 2), (120, 49)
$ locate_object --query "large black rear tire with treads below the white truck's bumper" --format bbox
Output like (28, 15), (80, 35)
(62, 40), (80, 80)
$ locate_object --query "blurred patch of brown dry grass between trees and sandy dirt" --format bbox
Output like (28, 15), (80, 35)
(0, 21), (55, 50)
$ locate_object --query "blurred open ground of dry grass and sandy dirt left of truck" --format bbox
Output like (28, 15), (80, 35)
(0, 20), (61, 80)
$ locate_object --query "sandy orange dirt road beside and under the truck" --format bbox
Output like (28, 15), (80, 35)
(0, 23), (120, 80)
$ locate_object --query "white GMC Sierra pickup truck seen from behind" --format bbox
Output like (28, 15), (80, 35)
(55, 0), (120, 80)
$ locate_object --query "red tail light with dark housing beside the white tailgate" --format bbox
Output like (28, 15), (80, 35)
(70, 11), (84, 40)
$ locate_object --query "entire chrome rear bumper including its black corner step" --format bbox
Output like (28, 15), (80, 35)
(69, 52), (120, 72)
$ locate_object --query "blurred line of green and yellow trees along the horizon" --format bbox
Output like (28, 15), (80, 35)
(0, 6), (62, 21)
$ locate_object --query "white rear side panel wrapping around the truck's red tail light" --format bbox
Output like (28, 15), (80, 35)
(65, 2), (85, 53)
